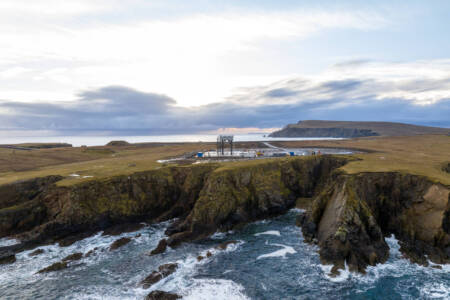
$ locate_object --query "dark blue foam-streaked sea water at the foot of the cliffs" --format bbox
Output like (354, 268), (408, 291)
(0, 210), (450, 300)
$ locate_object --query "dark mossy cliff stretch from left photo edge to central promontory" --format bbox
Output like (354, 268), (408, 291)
(0, 165), (217, 251)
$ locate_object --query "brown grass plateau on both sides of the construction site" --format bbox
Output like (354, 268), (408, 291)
(0, 135), (450, 185)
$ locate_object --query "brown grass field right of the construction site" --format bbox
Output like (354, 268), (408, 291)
(272, 135), (450, 185)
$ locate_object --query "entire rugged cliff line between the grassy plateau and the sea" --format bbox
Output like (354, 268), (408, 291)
(0, 156), (450, 272)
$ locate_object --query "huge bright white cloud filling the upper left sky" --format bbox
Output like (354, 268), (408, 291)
(0, 4), (390, 106)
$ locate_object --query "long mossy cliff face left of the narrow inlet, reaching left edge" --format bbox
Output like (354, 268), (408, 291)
(0, 156), (345, 251)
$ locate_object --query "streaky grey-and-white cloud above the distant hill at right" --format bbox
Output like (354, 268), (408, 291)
(228, 60), (450, 106)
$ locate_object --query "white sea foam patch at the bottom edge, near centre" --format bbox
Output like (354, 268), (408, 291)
(183, 279), (250, 300)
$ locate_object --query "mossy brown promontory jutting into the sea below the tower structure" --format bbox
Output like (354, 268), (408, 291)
(166, 156), (346, 247)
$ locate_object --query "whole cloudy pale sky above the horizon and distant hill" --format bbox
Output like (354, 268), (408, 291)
(0, 0), (450, 135)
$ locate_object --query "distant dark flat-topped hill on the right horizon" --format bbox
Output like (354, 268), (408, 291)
(270, 120), (450, 138)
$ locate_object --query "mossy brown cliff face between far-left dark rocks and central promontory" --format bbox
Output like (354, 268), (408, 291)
(15, 165), (217, 244)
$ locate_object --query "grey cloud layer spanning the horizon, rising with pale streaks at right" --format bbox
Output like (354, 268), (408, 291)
(0, 61), (450, 134)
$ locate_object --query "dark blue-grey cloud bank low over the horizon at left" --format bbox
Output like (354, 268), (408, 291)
(0, 86), (179, 132)
